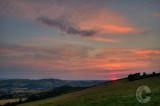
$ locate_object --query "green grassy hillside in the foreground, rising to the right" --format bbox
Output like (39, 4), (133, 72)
(21, 76), (160, 106)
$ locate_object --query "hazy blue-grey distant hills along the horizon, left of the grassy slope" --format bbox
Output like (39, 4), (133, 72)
(0, 79), (107, 92)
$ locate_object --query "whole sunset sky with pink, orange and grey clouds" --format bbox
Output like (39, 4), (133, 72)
(0, 0), (160, 80)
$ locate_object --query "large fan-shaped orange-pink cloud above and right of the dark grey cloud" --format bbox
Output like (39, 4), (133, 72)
(78, 8), (143, 35)
